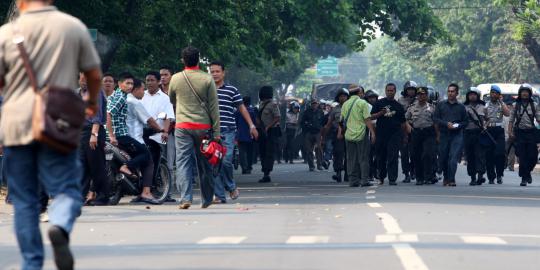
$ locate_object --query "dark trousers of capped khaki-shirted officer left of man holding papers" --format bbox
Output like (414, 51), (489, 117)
(410, 127), (435, 183)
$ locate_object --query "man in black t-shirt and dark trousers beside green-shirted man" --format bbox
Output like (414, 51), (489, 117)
(371, 83), (405, 186)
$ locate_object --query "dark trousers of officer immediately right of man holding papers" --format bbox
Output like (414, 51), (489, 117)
(463, 129), (486, 177)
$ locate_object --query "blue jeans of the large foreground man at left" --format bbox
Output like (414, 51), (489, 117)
(4, 143), (82, 269)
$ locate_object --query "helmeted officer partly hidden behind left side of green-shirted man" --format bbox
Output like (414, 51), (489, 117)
(323, 89), (349, 183)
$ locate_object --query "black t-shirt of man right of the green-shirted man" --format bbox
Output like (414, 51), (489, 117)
(371, 98), (405, 136)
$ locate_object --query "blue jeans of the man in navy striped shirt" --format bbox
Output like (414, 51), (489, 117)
(214, 129), (236, 201)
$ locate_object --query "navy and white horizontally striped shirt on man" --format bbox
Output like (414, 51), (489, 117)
(217, 84), (242, 130)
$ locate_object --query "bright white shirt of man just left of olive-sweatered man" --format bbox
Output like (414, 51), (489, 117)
(142, 89), (175, 144)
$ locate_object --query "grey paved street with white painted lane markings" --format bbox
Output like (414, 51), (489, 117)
(0, 164), (540, 270)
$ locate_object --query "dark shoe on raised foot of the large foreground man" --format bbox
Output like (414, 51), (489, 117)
(49, 225), (74, 270)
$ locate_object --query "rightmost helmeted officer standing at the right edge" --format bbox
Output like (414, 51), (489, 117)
(508, 84), (540, 187)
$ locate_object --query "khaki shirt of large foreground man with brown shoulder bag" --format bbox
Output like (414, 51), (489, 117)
(0, 6), (100, 146)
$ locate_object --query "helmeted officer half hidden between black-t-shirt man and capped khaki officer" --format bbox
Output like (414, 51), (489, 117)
(398, 81), (418, 183)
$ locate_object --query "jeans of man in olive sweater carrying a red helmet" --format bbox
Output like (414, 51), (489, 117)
(174, 129), (214, 205)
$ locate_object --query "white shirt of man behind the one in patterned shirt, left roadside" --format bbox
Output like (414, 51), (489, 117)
(126, 94), (151, 144)
